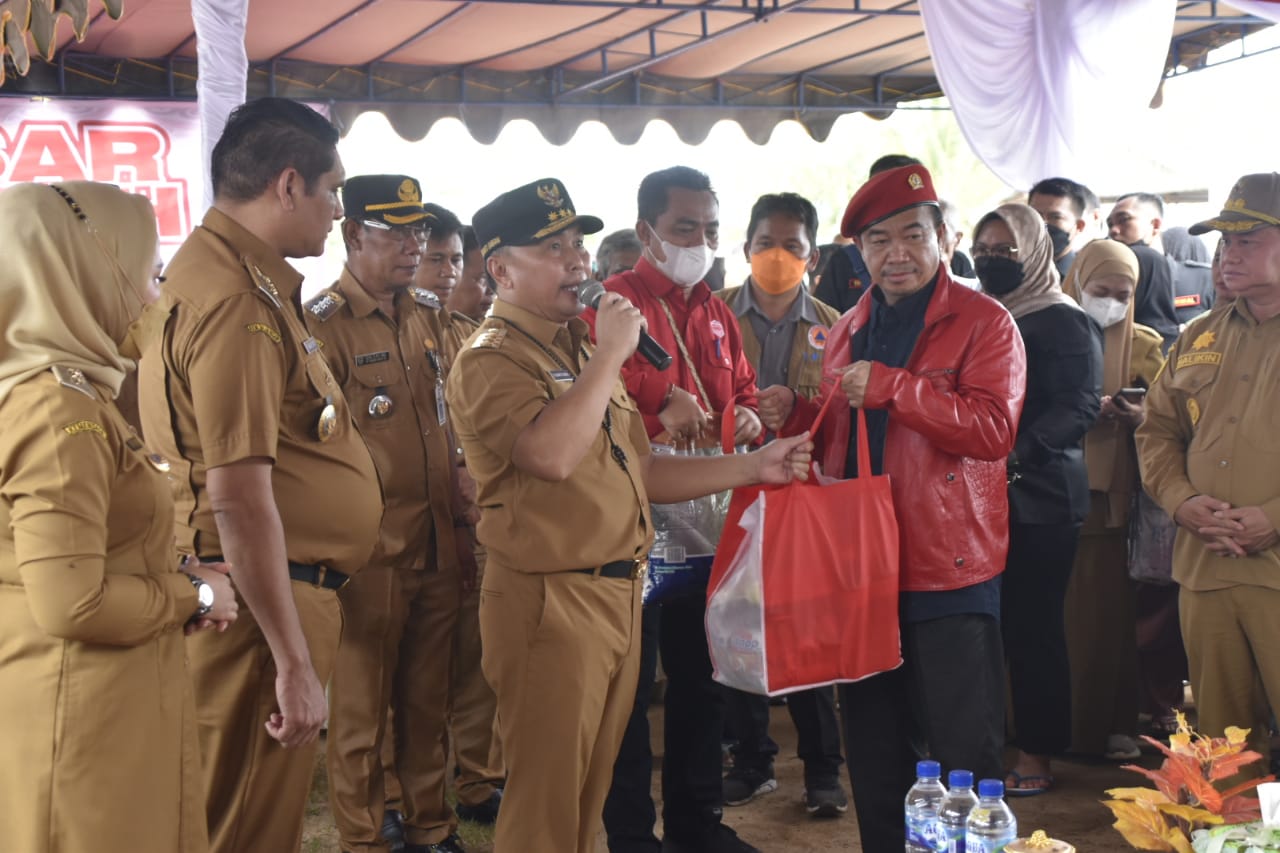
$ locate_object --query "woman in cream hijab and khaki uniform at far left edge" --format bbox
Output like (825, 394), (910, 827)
(0, 182), (236, 853)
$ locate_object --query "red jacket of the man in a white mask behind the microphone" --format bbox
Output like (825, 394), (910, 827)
(582, 257), (759, 438)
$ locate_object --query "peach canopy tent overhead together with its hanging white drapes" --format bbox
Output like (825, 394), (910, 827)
(0, 0), (1280, 192)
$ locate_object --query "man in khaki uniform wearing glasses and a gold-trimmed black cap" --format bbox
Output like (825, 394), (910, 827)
(305, 174), (474, 853)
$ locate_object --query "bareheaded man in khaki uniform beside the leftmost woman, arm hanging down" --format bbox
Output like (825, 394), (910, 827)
(140, 99), (383, 853)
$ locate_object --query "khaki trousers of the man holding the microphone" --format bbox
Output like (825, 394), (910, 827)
(480, 558), (644, 853)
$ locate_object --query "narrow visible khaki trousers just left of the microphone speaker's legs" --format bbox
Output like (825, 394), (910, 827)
(449, 547), (504, 806)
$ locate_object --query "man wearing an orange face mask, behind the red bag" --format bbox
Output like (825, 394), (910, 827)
(716, 192), (849, 817)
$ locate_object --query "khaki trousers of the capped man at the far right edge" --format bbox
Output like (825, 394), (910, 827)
(1178, 585), (1280, 758)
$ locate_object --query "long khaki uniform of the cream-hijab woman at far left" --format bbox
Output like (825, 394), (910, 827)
(0, 371), (207, 853)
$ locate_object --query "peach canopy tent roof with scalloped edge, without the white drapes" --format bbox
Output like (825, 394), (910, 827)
(0, 0), (1267, 142)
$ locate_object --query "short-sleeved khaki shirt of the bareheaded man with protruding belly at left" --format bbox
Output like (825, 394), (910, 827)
(138, 210), (383, 575)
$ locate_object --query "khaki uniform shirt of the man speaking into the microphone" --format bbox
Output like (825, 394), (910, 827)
(448, 301), (653, 573)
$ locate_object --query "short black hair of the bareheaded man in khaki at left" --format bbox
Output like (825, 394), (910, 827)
(209, 97), (338, 201)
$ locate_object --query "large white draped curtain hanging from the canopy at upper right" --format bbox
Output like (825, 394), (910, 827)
(920, 0), (1175, 190)
